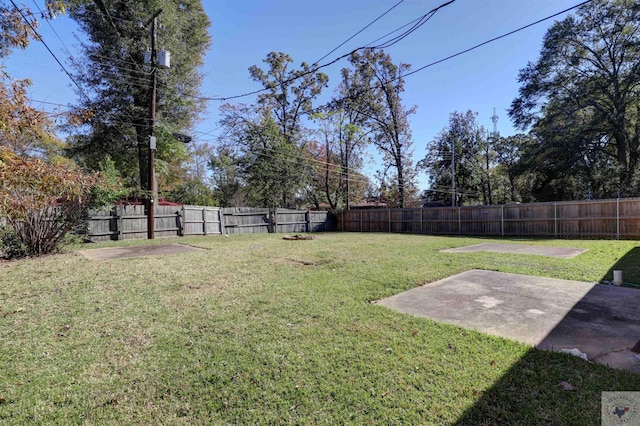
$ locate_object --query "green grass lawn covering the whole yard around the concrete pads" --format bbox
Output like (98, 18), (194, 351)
(0, 233), (640, 425)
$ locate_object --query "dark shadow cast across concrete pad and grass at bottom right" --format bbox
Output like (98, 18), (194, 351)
(455, 274), (640, 425)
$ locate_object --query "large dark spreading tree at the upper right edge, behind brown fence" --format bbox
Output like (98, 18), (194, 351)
(509, 0), (640, 194)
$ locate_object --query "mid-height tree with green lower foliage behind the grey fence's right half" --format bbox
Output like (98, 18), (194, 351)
(221, 52), (328, 207)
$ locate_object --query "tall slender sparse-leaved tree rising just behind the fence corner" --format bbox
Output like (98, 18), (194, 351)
(347, 49), (416, 207)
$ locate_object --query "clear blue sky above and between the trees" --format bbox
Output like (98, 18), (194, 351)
(5, 0), (580, 189)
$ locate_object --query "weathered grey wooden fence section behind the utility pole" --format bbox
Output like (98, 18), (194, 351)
(87, 205), (336, 241)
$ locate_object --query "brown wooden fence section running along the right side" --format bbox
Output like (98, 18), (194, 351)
(338, 198), (640, 239)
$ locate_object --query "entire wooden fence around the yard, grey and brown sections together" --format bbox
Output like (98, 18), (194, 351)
(71, 198), (640, 241)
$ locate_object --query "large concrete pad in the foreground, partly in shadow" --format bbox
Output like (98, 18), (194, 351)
(376, 270), (640, 373)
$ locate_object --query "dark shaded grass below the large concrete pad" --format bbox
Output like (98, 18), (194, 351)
(454, 348), (640, 426)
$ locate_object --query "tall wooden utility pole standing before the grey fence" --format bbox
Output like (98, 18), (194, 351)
(145, 9), (162, 240)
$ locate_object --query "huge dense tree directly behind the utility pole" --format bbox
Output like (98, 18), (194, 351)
(58, 0), (211, 189)
